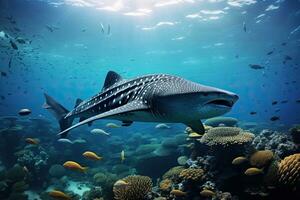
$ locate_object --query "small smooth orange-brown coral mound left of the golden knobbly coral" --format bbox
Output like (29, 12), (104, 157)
(250, 150), (274, 167)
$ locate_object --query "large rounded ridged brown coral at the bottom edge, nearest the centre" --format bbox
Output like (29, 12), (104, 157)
(113, 175), (152, 200)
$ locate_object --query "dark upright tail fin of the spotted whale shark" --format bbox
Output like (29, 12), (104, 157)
(43, 93), (74, 138)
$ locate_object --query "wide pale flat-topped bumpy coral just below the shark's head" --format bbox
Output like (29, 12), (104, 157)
(200, 127), (254, 146)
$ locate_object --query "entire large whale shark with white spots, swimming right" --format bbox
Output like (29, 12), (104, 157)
(43, 71), (239, 138)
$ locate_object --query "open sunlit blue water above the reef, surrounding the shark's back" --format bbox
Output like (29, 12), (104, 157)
(0, 0), (300, 124)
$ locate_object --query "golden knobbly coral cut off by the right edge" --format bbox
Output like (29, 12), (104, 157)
(278, 153), (300, 189)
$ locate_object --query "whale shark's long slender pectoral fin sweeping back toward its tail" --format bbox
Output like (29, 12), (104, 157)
(58, 101), (149, 136)
